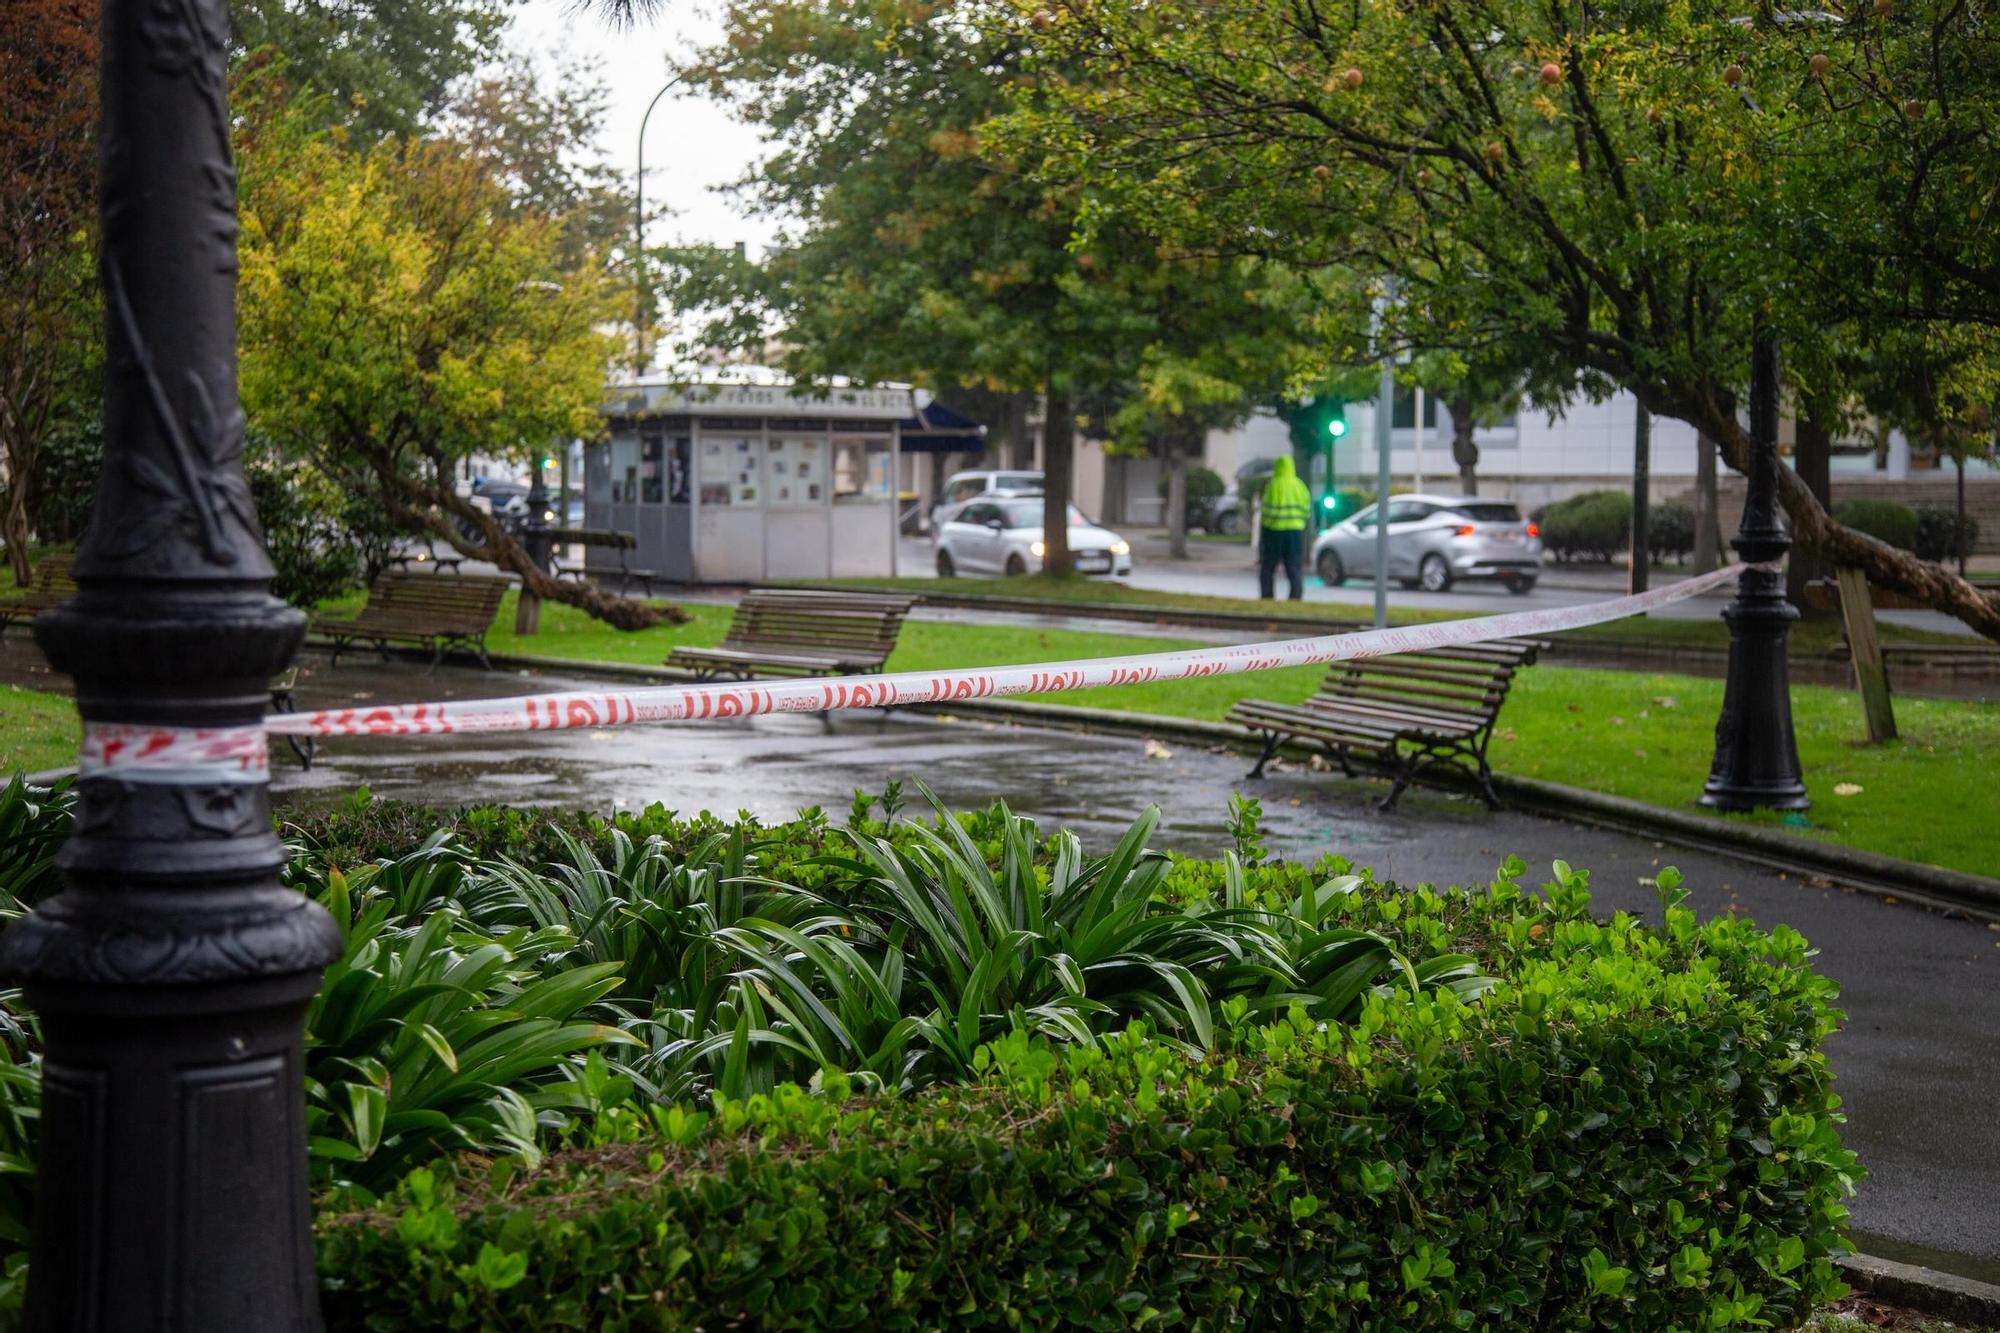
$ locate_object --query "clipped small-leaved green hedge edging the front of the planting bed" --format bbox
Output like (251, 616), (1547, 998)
(322, 863), (1858, 1331)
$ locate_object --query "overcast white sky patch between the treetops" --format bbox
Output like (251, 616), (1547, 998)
(510, 0), (772, 256)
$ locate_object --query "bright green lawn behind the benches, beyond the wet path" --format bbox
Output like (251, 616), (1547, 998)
(458, 586), (2000, 875)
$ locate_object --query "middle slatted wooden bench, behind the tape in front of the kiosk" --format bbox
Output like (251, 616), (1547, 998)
(666, 590), (916, 681)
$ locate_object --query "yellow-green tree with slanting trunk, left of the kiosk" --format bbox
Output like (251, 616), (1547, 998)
(240, 83), (656, 626)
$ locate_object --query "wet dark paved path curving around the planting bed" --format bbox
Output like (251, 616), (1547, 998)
(262, 648), (2000, 1277)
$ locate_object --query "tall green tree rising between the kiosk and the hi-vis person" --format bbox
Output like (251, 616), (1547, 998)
(678, 0), (1336, 566)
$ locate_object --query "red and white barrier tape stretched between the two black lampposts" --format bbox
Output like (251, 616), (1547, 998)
(246, 564), (1748, 737)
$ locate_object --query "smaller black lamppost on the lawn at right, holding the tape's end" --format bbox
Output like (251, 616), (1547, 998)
(1702, 330), (1812, 811)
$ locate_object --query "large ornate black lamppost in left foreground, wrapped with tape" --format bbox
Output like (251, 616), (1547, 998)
(0, 0), (340, 1329)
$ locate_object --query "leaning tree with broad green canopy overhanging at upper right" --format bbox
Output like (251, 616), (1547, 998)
(1006, 0), (2000, 638)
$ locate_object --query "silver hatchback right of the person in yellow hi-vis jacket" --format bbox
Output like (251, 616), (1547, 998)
(1312, 494), (1542, 592)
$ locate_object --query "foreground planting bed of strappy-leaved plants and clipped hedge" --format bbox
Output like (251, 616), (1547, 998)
(0, 785), (1858, 1331)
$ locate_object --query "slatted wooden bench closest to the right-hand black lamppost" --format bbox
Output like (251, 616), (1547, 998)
(1230, 638), (1542, 811)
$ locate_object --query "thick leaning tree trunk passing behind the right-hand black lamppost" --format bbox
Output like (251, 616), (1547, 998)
(1654, 384), (2000, 642)
